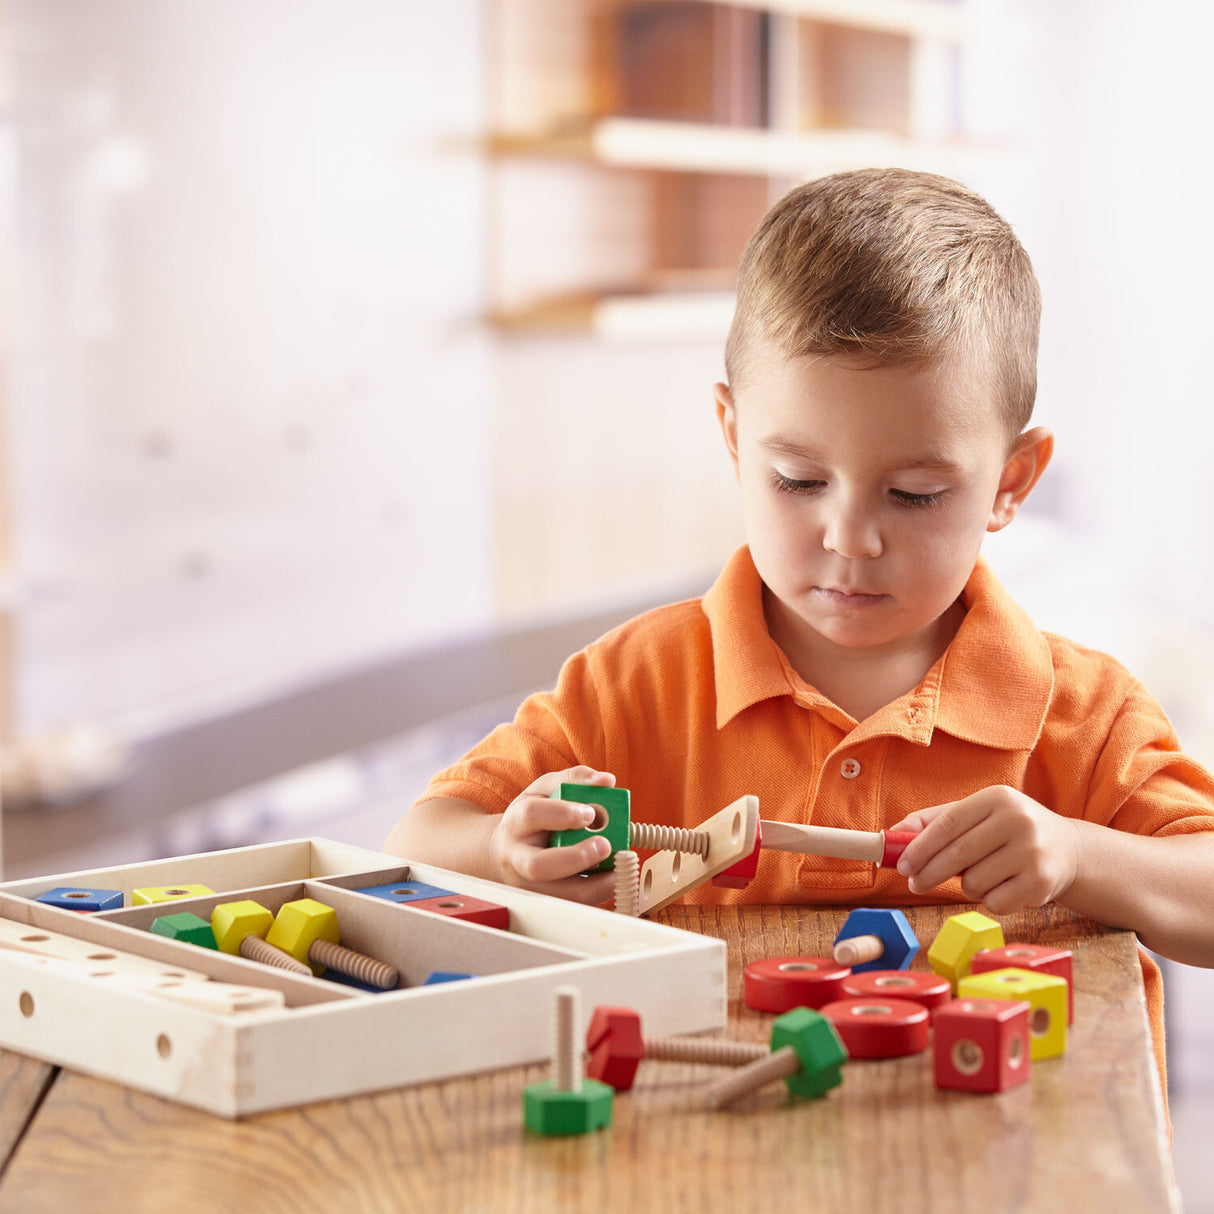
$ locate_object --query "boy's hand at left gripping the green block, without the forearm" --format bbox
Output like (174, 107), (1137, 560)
(489, 767), (615, 906)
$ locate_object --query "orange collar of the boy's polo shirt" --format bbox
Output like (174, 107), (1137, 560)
(702, 546), (1054, 750)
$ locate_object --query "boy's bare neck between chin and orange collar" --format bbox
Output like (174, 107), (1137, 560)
(764, 589), (965, 722)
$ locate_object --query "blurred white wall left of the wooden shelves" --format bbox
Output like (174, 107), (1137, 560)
(4, 0), (492, 732)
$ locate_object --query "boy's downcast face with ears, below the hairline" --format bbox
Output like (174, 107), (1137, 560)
(717, 350), (1050, 664)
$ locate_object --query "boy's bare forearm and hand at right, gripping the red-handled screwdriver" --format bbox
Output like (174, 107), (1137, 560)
(892, 787), (1214, 968)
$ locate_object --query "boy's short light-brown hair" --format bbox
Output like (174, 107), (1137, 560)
(725, 169), (1042, 435)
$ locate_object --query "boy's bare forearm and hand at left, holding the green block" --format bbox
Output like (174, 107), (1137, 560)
(384, 767), (615, 906)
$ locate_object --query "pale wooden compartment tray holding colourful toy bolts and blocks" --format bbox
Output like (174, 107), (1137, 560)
(0, 839), (726, 1117)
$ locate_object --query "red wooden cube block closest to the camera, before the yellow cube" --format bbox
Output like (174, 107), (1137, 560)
(932, 999), (1031, 1091)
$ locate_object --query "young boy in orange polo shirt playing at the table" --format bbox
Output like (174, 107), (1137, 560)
(386, 170), (1214, 965)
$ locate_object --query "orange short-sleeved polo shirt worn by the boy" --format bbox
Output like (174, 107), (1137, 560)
(421, 548), (1214, 1112)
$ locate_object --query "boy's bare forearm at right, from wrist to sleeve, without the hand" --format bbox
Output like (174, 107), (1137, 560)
(1056, 821), (1214, 968)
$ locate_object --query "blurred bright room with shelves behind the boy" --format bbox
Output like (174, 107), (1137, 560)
(0, 0), (1214, 1212)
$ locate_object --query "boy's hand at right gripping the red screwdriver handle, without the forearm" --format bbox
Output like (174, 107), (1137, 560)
(890, 785), (1079, 914)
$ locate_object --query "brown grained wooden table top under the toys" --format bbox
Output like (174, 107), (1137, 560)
(0, 907), (1175, 1214)
